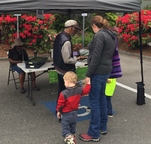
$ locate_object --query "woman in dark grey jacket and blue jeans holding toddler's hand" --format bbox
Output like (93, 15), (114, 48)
(79, 16), (116, 142)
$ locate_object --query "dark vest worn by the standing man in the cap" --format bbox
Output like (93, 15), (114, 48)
(53, 32), (75, 73)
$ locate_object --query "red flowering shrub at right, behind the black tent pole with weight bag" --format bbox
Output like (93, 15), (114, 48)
(116, 10), (151, 48)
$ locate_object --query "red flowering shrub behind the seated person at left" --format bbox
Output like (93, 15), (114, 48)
(0, 14), (55, 52)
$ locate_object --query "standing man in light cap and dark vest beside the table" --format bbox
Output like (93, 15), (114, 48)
(53, 20), (80, 108)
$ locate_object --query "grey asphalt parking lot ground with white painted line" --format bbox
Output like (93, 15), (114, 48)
(0, 52), (151, 144)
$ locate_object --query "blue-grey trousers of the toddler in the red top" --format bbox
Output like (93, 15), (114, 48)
(61, 111), (77, 137)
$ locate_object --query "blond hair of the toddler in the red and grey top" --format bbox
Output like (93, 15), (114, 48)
(63, 71), (77, 84)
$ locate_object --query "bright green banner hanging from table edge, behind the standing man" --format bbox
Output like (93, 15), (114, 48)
(49, 66), (88, 83)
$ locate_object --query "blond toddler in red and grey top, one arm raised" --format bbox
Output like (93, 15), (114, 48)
(56, 71), (91, 144)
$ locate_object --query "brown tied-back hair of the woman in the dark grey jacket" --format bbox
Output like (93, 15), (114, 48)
(91, 15), (110, 29)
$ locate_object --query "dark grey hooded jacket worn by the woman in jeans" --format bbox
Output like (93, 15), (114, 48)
(86, 30), (116, 77)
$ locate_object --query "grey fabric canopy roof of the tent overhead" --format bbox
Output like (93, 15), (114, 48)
(0, 0), (141, 14)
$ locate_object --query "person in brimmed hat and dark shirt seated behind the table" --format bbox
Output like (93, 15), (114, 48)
(8, 38), (40, 94)
